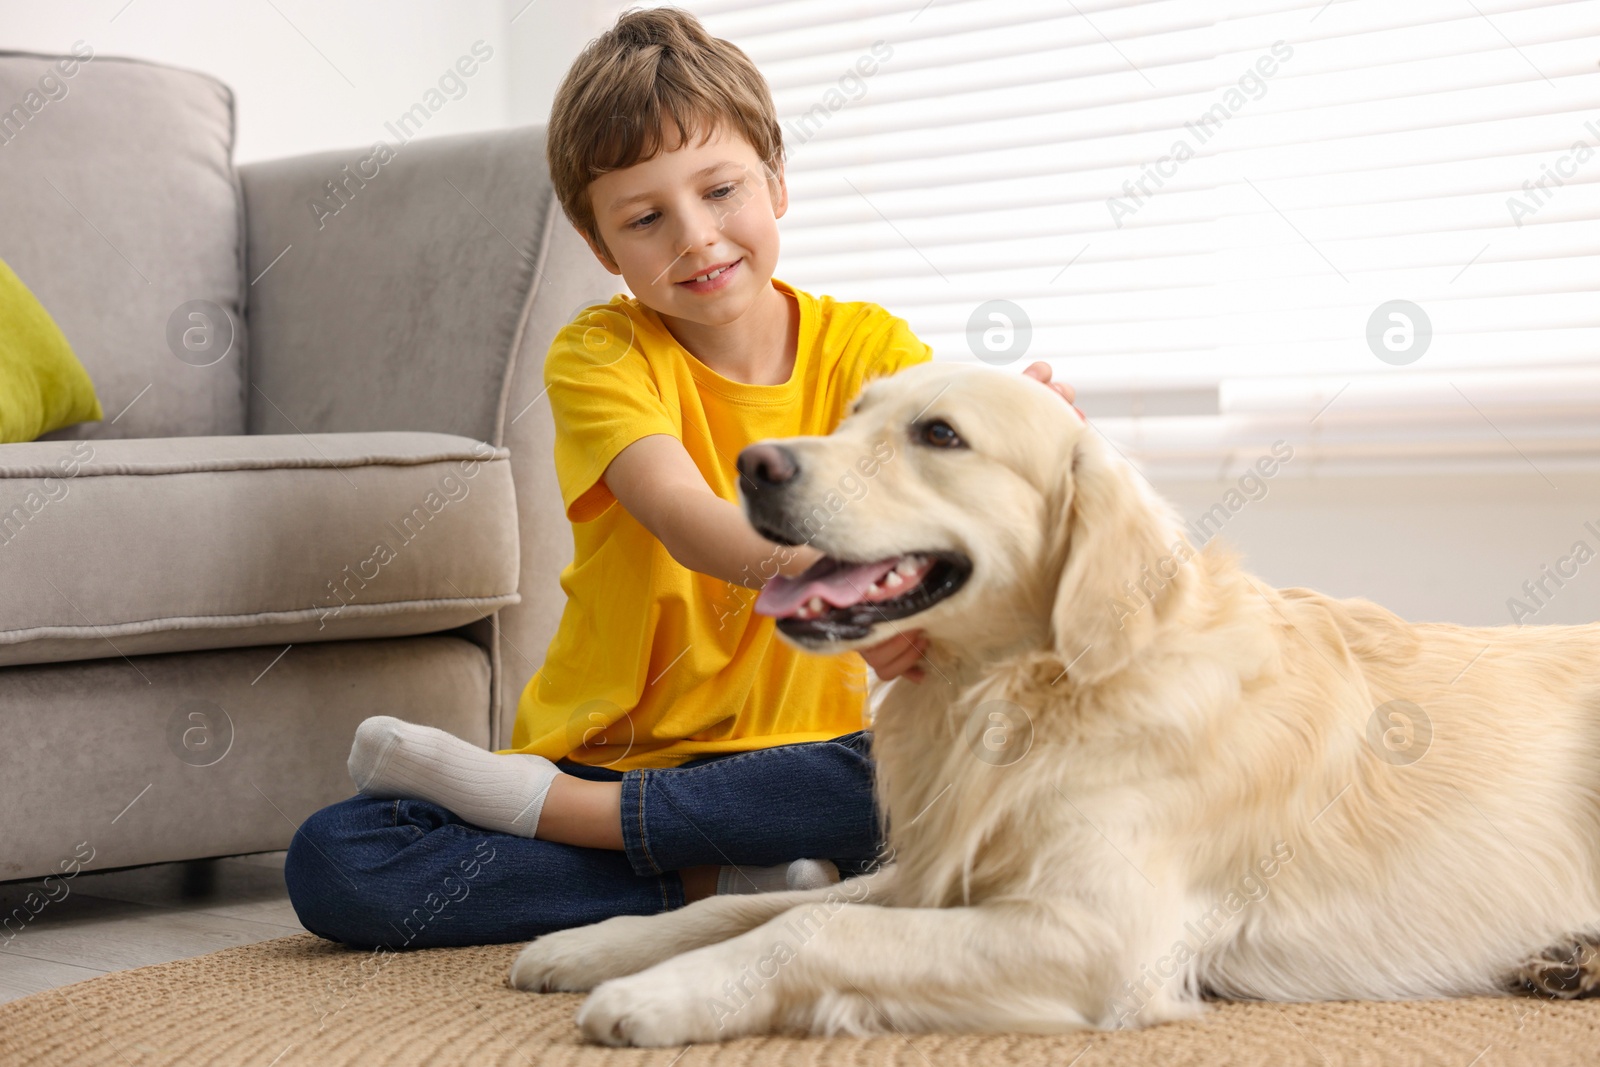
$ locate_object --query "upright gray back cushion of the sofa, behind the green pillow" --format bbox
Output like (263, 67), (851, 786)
(0, 42), (246, 440)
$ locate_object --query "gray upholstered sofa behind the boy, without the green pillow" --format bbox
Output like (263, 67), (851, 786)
(0, 53), (621, 880)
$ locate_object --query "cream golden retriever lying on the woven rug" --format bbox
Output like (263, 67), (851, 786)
(510, 363), (1600, 1046)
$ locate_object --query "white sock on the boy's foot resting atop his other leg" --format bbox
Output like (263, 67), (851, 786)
(349, 715), (560, 837)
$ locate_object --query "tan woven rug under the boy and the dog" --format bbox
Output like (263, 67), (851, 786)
(0, 934), (1600, 1067)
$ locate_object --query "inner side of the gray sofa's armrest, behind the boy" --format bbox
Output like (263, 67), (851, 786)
(240, 126), (550, 441)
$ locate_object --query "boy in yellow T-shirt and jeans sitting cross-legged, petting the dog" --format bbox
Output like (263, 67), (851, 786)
(285, 8), (1070, 947)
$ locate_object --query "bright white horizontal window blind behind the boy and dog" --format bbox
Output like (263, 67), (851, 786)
(618, 0), (1600, 472)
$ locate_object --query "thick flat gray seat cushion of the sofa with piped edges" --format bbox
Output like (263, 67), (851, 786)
(0, 432), (520, 665)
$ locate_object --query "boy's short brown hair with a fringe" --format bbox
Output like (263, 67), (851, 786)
(544, 8), (784, 268)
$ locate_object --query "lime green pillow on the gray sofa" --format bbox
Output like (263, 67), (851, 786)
(0, 259), (106, 445)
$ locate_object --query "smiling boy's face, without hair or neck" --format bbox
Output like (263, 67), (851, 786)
(586, 126), (789, 325)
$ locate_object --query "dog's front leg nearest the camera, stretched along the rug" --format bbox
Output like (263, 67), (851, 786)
(578, 883), (1118, 1046)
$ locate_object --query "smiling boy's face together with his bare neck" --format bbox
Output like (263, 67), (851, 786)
(589, 122), (790, 381)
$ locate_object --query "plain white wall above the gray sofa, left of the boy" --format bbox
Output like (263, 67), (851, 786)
(0, 0), (619, 163)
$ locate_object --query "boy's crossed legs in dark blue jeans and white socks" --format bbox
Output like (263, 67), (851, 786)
(285, 720), (880, 949)
